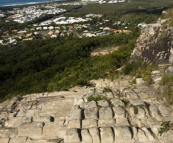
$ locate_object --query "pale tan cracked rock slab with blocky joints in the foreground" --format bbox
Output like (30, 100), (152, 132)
(0, 80), (173, 143)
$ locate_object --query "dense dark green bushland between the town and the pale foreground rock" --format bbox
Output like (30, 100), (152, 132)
(0, 33), (138, 98)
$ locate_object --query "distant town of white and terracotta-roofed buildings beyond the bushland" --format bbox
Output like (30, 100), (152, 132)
(0, 0), (131, 45)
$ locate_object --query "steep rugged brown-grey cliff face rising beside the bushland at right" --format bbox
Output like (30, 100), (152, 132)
(131, 24), (173, 64)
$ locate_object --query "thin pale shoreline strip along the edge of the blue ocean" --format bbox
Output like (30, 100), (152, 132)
(0, 0), (77, 8)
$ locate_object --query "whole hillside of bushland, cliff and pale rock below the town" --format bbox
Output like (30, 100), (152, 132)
(0, 1), (173, 143)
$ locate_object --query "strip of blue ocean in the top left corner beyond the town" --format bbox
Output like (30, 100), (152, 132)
(0, 0), (66, 6)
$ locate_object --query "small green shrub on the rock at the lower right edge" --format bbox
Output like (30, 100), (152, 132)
(158, 121), (173, 136)
